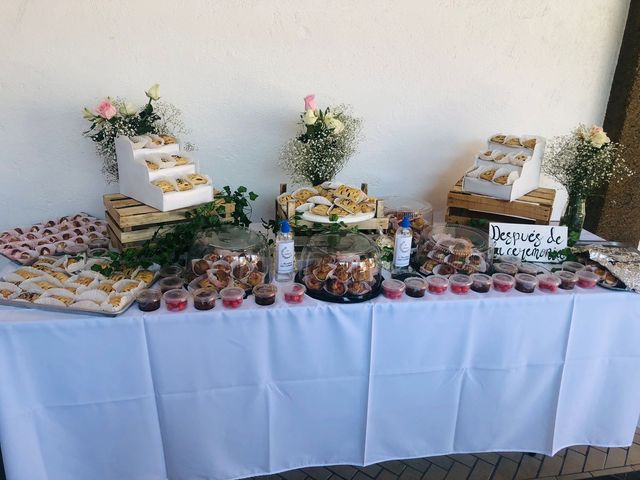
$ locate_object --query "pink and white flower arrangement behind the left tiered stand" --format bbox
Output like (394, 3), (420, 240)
(82, 84), (194, 182)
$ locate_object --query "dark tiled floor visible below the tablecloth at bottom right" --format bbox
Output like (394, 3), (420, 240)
(251, 429), (640, 480)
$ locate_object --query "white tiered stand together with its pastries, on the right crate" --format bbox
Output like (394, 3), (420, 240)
(462, 134), (546, 201)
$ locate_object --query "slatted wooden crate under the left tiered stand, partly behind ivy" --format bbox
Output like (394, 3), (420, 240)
(103, 193), (235, 250)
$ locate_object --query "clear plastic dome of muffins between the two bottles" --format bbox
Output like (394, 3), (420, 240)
(297, 231), (382, 303)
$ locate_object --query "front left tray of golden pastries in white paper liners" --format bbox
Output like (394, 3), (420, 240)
(0, 253), (158, 317)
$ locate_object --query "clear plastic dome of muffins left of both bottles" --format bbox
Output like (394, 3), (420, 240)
(188, 225), (270, 291)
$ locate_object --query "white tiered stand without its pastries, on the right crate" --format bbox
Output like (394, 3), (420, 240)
(462, 136), (546, 201)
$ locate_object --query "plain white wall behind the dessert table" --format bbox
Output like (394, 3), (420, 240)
(0, 0), (629, 229)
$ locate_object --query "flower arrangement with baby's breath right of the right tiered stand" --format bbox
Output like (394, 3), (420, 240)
(543, 125), (633, 198)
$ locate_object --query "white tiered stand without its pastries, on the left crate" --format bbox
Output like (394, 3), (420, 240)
(116, 136), (213, 212)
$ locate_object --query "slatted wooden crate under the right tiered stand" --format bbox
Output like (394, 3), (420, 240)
(445, 180), (556, 225)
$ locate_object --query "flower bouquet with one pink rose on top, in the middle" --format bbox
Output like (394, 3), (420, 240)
(280, 95), (362, 185)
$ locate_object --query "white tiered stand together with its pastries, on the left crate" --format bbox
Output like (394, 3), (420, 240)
(116, 135), (213, 212)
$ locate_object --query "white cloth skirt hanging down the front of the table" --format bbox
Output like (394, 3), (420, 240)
(0, 289), (640, 480)
